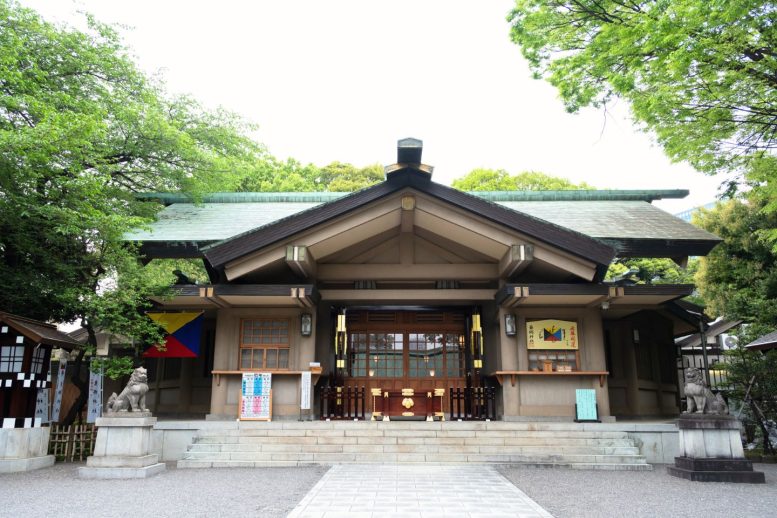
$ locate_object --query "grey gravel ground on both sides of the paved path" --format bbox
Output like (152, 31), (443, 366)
(0, 463), (777, 518)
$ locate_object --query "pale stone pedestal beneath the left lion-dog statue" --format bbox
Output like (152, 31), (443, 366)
(78, 412), (165, 478)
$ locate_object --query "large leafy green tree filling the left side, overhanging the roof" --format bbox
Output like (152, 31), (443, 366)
(0, 0), (266, 418)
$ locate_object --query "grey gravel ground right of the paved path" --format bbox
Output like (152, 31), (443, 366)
(499, 464), (777, 518)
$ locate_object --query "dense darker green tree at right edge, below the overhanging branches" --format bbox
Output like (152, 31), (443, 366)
(694, 200), (777, 341)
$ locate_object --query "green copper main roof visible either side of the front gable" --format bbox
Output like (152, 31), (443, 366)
(125, 191), (720, 258)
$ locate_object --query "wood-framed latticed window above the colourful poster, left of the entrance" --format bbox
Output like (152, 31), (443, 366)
(240, 318), (289, 370)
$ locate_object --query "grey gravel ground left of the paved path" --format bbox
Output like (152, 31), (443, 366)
(0, 463), (329, 518)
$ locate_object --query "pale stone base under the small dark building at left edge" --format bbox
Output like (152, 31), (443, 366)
(0, 427), (54, 473)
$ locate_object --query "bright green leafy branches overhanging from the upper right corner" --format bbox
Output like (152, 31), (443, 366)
(508, 0), (777, 243)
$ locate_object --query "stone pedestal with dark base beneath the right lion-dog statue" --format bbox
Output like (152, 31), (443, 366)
(667, 414), (765, 484)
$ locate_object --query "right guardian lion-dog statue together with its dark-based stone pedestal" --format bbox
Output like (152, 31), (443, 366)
(667, 368), (765, 483)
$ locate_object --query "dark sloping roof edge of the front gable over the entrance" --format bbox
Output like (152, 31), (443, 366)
(204, 165), (615, 268)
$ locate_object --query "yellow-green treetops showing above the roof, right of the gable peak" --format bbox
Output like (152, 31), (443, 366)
(451, 169), (593, 191)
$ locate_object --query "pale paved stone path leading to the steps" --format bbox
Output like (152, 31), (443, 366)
(288, 464), (552, 518)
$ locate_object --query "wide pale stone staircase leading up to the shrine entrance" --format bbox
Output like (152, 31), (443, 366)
(178, 421), (653, 470)
